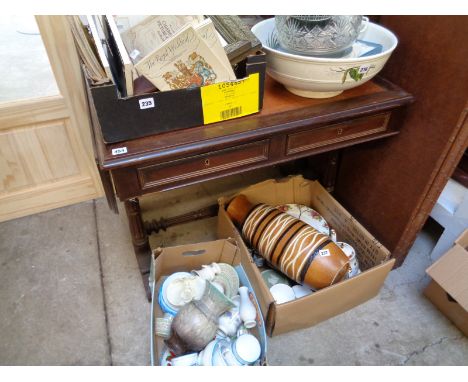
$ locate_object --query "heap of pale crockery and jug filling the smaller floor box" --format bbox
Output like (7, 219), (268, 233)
(155, 263), (261, 366)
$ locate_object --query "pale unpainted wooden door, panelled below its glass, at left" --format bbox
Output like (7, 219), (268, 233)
(0, 16), (103, 221)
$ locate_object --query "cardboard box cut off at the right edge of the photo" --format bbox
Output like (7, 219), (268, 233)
(424, 229), (468, 336)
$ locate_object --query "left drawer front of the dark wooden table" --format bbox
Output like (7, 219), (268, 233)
(137, 140), (270, 190)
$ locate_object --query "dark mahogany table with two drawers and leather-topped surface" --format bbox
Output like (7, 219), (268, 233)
(91, 76), (413, 298)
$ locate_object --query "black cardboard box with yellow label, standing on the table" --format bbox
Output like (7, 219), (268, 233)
(86, 17), (266, 143)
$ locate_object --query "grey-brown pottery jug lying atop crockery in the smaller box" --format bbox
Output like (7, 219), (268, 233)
(164, 282), (235, 355)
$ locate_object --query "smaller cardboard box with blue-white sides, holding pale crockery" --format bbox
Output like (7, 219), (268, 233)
(149, 239), (267, 366)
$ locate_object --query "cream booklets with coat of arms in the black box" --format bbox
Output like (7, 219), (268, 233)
(113, 16), (236, 97)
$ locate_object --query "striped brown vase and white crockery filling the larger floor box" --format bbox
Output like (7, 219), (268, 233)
(227, 195), (360, 304)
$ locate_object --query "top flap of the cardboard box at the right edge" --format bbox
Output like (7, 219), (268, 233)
(426, 230), (468, 311)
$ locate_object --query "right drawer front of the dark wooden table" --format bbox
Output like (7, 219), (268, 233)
(286, 113), (390, 155)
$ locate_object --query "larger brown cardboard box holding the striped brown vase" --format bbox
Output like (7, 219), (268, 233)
(218, 176), (395, 336)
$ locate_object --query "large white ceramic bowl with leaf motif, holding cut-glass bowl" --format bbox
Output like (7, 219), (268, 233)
(252, 18), (398, 98)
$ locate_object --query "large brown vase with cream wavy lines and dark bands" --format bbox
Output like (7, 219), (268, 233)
(226, 195), (349, 289)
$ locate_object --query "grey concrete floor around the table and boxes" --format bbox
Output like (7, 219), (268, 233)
(0, 171), (468, 365)
